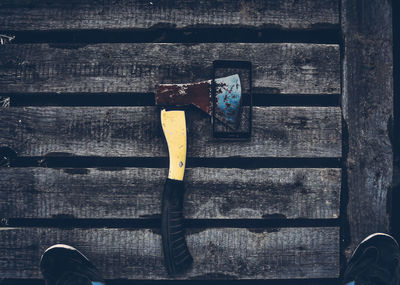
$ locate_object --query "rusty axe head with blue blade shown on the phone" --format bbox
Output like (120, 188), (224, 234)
(156, 74), (242, 128)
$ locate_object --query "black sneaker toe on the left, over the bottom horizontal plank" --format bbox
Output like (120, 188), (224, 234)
(40, 244), (105, 285)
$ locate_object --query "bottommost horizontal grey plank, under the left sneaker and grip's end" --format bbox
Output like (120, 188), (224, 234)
(0, 227), (339, 279)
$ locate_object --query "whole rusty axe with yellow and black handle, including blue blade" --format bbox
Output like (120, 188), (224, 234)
(156, 74), (242, 275)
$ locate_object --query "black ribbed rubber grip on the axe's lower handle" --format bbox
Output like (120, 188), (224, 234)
(161, 178), (193, 275)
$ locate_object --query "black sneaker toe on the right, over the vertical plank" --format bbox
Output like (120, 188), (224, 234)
(343, 233), (400, 285)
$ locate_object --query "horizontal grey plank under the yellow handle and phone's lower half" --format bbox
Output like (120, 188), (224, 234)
(0, 107), (341, 157)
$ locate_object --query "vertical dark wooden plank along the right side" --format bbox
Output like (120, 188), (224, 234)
(342, 0), (393, 257)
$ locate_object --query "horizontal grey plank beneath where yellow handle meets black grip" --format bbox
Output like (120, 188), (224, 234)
(0, 165), (341, 219)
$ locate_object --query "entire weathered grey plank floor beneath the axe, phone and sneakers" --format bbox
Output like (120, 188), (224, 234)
(0, 0), (393, 285)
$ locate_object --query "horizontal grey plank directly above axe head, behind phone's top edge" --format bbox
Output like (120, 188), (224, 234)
(0, 43), (340, 94)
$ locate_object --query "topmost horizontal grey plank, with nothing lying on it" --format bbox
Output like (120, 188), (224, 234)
(0, 0), (339, 31)
